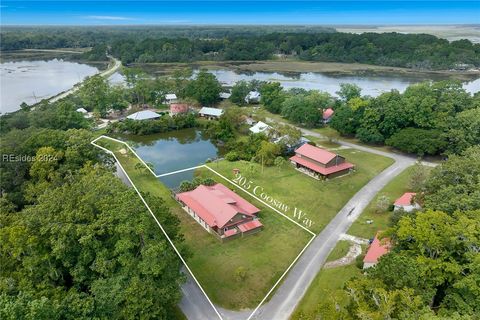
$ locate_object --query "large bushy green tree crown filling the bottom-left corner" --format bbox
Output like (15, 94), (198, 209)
(0, 166), (183, 319)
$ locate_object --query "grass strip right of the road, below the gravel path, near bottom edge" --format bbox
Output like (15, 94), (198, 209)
(290, 241), (362, 320)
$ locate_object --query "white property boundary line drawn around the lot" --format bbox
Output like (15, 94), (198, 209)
(91, 135), (316, 320)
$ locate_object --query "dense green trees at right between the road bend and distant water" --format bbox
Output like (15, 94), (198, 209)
(255, 81), (480, 156)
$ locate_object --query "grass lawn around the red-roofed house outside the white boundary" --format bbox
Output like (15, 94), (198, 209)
(200, 149), (393, 233)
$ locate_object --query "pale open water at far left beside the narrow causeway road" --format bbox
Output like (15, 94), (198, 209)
(0, 59), (98, 114)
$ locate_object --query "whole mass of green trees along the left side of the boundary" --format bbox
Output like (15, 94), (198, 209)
(0, 98), (184, 320)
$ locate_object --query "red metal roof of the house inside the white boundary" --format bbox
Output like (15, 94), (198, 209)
(177, 183), (260, 228)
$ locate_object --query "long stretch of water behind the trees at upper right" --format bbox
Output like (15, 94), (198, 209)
(194, 69), (480, 97)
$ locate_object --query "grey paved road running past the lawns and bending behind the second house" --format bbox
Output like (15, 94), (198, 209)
(180, 119), (435, 320)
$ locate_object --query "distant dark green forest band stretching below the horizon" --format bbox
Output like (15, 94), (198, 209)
(0, 27), (480, 70)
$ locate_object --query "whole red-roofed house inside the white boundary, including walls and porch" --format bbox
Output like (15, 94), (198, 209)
(175, 183), (263, 240)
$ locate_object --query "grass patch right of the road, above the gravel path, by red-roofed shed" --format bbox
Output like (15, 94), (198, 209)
(348, 167), (430, 239)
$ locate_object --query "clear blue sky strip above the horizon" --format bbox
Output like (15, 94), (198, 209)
(0, 0), (480, 25)
